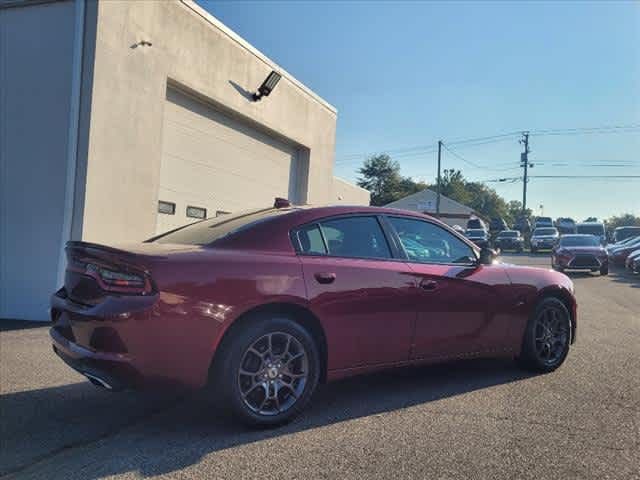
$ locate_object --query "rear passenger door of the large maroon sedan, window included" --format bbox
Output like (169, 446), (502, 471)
(294, 215), (416, 370)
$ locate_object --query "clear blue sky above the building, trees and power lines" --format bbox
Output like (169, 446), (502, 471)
(199, 0), (640, 220)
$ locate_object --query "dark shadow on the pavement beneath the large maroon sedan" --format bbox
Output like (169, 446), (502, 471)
(2, 359), (531, 479)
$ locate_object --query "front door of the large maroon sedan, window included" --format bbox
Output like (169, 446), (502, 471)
(385, 216), (509, 359)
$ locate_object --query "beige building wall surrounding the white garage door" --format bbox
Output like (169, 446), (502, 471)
(82, 0), (336, 243)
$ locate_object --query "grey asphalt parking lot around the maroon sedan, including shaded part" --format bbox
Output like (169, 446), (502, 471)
(0, 254), (640, 479)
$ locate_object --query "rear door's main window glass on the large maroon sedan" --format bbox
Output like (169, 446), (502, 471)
(320, 216), (391, 259)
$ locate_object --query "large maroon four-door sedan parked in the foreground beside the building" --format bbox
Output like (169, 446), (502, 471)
(51, 204), (576, 425)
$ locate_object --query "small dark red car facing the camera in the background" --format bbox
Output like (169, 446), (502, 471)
(551, 234), (609, 275)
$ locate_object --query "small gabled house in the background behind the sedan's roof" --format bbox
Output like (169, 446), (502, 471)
(385, 189), (480, 228)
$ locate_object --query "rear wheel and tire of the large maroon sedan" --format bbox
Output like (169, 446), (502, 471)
(210, 315), (320, 428)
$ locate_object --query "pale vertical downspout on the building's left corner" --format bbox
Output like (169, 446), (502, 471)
(58, 0), (85, 285)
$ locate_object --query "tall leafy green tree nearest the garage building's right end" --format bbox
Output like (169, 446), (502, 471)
(358, 154), (427, 206)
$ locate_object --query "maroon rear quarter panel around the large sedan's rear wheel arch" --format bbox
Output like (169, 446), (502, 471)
(149, 249), (306, 386)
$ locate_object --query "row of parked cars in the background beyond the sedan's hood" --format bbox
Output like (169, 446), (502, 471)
(465, 217), (640, 275)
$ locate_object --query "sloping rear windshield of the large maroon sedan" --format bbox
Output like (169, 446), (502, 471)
(149, 208), (292, 245)
